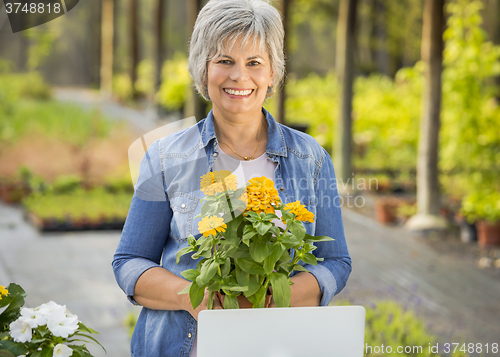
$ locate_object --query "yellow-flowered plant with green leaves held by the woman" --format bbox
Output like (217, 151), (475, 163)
(177, 170), (333, 309)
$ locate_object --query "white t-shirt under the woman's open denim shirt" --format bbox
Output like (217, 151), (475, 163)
(189, 148), (285, 357)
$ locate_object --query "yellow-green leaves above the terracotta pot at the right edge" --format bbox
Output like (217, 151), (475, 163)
(462, 189), (500, 223)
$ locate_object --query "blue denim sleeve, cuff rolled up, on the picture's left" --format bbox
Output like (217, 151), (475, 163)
(112, 142), (172, 304)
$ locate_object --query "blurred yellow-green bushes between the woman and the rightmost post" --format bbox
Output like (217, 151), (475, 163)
(286, 71), (421, 170)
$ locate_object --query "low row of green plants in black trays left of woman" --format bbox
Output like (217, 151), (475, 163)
(23, 186), (132, 222)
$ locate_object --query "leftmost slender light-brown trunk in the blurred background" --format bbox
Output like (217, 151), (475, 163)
(100, 0), (114, 95)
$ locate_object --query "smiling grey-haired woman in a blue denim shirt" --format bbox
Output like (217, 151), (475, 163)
(113, 0), (351, 357)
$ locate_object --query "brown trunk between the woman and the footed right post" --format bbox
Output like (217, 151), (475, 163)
(333, 0), (357, 189)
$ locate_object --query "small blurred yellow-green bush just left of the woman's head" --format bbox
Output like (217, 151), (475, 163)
(157, 52), (191, 110)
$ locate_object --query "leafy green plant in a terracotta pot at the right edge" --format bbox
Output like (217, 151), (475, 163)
(461, 190), (500, 246)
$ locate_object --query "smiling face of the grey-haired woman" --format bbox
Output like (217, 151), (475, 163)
(207, 37), (273, 116)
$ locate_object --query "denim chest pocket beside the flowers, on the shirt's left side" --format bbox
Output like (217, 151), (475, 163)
(170, 193), (199, 243)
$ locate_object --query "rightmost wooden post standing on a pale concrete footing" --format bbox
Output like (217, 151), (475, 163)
(406, 0), (446, 231)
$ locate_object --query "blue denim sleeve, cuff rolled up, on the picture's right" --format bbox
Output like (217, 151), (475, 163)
(305, 149), (352, 306)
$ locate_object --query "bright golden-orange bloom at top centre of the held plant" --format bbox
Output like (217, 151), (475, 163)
(242, 176), (280, 214)
